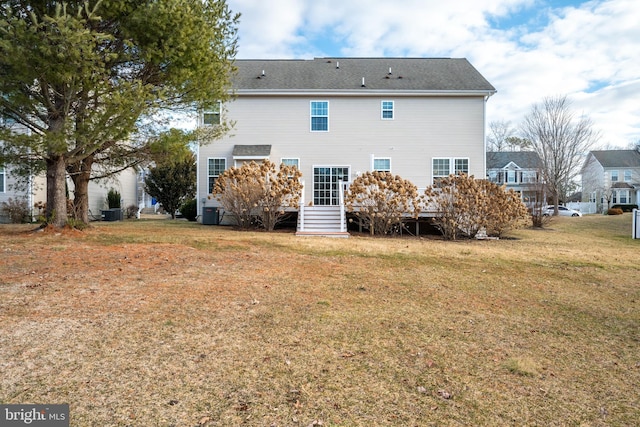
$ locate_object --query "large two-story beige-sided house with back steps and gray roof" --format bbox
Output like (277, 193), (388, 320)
(197, 58), (496, 234)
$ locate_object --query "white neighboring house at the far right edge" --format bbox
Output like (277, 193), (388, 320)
(582, 147), (640, 212)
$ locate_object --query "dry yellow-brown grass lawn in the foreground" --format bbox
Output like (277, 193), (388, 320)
(0, 213), (640, 427)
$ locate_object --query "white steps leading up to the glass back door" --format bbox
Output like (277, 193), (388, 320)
(296, 206), (349, 237)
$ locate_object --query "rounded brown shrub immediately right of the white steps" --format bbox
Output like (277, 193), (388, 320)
(345, 171), (420, 235)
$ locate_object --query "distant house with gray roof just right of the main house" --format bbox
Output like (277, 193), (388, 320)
(487, 151), (545, 207)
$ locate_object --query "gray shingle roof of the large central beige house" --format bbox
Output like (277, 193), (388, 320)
(232, 58), (496, 94)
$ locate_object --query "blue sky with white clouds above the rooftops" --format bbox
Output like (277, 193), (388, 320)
(227, 0), (640, 148)
